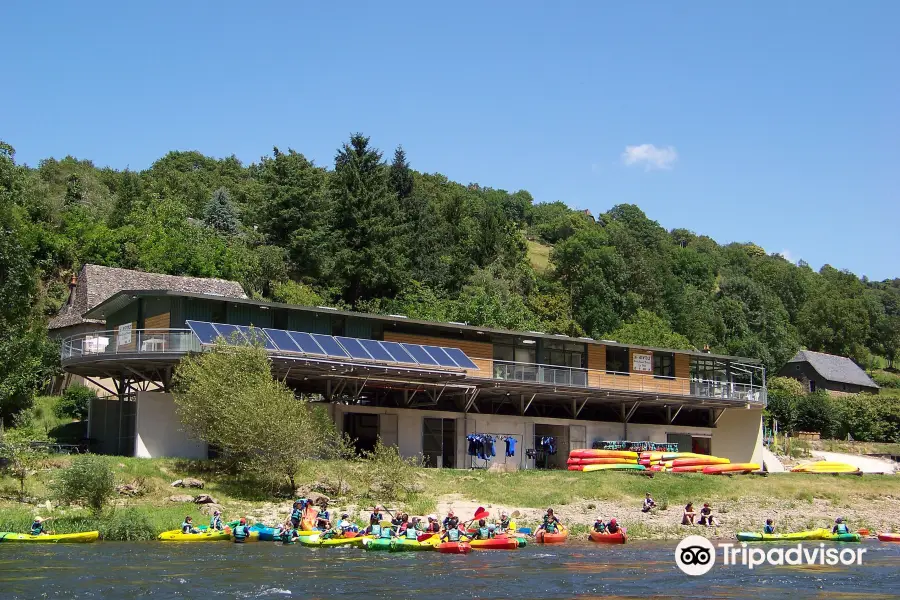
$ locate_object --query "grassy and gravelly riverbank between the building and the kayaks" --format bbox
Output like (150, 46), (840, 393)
(0, 457), (900, 539)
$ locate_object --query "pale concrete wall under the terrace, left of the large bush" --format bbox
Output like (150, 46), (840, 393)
(134, 392), (207, 458)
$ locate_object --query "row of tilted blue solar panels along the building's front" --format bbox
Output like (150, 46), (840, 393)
(187, 321), (478, 370)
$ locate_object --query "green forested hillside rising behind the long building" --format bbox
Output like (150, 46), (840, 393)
(0, 135), (900, 415)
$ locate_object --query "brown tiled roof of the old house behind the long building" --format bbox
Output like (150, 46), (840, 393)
(50, 265), (247, 329)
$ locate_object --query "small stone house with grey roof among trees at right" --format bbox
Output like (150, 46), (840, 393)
(778, 350), (879, 395)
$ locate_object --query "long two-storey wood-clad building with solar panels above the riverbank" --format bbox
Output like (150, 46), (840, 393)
(56, 278), (766, 469)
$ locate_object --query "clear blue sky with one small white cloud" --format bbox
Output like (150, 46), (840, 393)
(0, 0), (900, 280)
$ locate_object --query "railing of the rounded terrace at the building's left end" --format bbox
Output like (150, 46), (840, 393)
(60, 329), (200, 361)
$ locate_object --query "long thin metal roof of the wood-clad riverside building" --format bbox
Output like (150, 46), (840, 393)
(83, 289), (761, 365)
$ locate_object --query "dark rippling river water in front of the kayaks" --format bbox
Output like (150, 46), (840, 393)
(0, 542), (900, 600)
